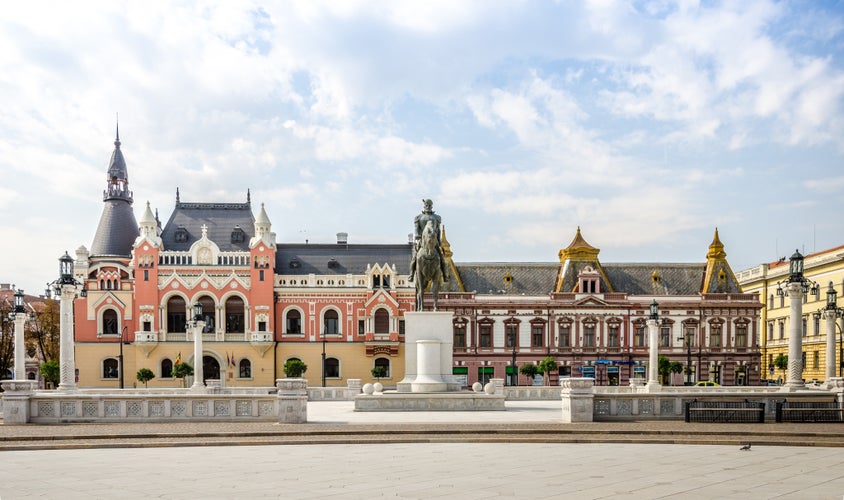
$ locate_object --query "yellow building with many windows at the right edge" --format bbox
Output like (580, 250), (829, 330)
(736, 246), (844, 382)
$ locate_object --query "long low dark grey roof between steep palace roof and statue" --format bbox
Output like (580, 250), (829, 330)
(275, 243), (413, 275)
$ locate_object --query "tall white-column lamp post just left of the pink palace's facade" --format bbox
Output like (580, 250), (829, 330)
(49, 252), (88, 392)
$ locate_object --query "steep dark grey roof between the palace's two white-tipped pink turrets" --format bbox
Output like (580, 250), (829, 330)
(161, 201), (255, 252)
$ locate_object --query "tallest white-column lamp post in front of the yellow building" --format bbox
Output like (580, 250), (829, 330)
(777, 250), (820, 390)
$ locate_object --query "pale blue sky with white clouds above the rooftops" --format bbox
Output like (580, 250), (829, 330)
(0, 0), (844, 294)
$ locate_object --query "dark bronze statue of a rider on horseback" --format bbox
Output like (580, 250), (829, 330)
(408, 199), (448, 311)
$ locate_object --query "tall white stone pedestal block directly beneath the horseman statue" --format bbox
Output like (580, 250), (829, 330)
(396, 311), (454, 392)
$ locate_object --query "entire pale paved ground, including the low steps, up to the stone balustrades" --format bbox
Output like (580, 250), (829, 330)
(0, 401), (844, 500)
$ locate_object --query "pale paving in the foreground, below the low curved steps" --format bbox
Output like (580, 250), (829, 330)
(0, 443), (844, 500)
